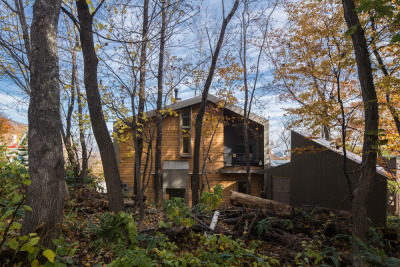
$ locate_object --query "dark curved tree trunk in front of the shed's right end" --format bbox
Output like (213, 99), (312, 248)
(342, 0), (379, 266)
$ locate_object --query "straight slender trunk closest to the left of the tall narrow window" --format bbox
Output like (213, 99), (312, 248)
(154, 0), (166, 205)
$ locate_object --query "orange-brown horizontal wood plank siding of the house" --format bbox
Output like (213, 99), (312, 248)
(117, 100), (264, 204)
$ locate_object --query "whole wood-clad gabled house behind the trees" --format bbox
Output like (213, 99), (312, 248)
(114, 95), (269, 204)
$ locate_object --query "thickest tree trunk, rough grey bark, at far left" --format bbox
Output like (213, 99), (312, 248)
(22, 0), (65, 247)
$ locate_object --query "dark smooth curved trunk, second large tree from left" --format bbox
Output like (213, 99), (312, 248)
(76, 0), (124, 212)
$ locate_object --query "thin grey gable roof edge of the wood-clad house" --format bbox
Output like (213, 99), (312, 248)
(147, 94), (268, 125)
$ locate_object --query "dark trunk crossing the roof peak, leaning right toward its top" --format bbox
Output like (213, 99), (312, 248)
(192, 0), (239, 206)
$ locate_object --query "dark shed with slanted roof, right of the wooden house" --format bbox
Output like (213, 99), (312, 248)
(264, 131), (387, 225)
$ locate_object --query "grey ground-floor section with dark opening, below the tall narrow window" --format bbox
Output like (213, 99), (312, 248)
(162, 160), (189, 204)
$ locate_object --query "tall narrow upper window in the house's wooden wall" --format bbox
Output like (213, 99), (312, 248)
(180, 108), (192, 156)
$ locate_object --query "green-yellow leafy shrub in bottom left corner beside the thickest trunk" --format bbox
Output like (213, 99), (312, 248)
(0, 161), (75, 266)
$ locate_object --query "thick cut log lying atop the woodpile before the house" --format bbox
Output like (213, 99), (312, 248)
(231, 191), (291, 213)
